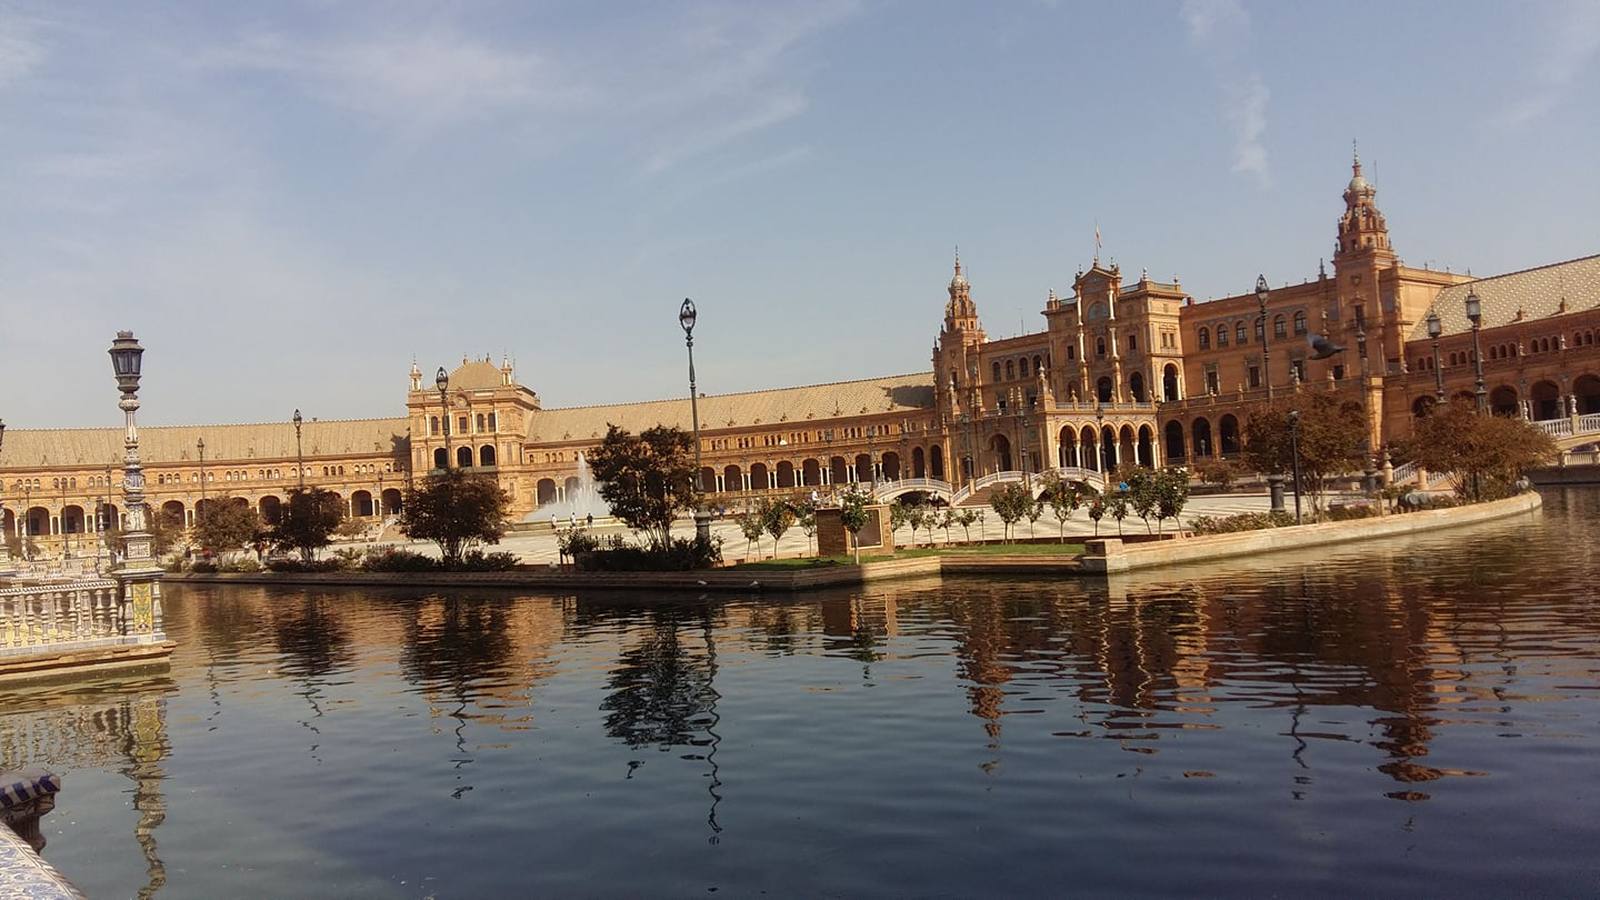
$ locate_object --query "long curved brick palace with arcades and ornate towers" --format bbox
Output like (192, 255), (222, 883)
(9, 150), (1600, 548)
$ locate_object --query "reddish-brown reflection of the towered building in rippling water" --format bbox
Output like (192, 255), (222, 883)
(908, 552), (1512, 801)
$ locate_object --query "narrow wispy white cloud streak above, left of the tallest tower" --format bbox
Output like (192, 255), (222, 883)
(1179, 0), (1272, 187)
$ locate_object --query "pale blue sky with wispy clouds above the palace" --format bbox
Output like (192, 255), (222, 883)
(0, 0), (1600, 428)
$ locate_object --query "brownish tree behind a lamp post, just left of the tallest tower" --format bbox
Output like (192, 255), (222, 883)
(1245, 391), (1366, 511)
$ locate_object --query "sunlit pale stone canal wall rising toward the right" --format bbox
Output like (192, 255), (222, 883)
(1082, 490), (1544, 575)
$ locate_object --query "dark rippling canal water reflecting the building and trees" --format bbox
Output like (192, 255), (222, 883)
(0, 488), (1600, 898)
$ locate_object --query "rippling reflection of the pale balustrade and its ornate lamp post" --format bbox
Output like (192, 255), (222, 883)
(0, 674), (176, 900)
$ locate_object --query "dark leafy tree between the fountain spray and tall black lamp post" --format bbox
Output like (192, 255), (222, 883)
(589, 424), (699, 549)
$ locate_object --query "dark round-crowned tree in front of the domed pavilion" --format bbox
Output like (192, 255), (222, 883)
(400, 469), (510, 569)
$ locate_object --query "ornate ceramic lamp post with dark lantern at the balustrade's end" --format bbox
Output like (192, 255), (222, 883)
(109, 331), (166, 642)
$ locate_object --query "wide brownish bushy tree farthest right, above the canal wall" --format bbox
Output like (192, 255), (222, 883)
(1400, 402), (1558, 501)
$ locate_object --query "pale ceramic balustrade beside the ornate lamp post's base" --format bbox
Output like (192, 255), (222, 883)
(0, 578), (128, 655)
